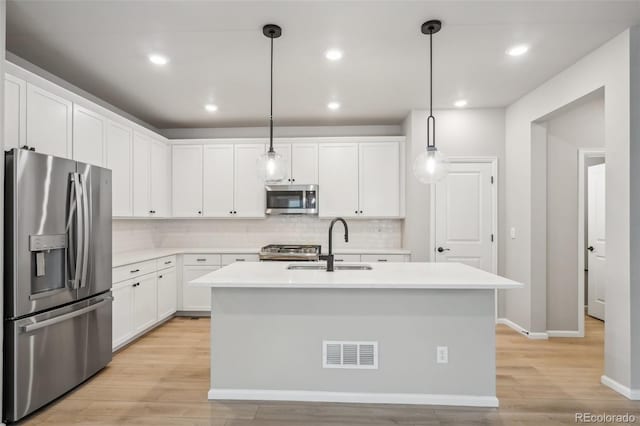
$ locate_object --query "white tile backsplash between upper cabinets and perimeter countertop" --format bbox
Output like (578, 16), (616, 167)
(113, 216), (402, 251)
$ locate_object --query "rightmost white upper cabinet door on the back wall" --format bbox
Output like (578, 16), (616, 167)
(358, 142), (400, 217)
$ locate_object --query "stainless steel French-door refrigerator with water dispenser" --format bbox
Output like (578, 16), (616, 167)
(3, 149), (113, 422)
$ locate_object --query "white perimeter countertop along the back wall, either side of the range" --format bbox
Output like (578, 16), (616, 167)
(111, 247), (411, 268)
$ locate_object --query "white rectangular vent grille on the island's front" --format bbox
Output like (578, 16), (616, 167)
(322, 340), (378, 369)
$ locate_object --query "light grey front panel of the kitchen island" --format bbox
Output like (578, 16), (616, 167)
(211, 288), (496, 405)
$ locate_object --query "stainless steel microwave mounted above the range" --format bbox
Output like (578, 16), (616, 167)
(265, 185), (318, 215)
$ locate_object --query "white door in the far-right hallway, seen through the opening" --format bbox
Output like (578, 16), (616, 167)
(587, 164), (607, 321)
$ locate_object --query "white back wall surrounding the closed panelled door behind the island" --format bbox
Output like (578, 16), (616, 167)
(402, 109), (505, 270)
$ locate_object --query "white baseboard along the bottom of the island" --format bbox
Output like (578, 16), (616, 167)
(209, 389), (498, 407)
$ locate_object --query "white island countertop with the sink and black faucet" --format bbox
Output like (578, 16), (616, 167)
(189, 262), (523, 290)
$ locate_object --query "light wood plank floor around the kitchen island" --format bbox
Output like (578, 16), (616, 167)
(25, 318), (640, 426)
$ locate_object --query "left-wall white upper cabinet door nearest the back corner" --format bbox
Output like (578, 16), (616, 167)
(150, 141), (171, 217)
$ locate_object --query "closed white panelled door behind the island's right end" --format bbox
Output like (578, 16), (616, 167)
(434, 163), (496, 273)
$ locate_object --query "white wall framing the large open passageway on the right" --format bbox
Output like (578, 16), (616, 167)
(504, 30), (640, 394)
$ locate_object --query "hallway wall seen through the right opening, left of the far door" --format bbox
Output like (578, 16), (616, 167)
(546, 95), (605, 331)
